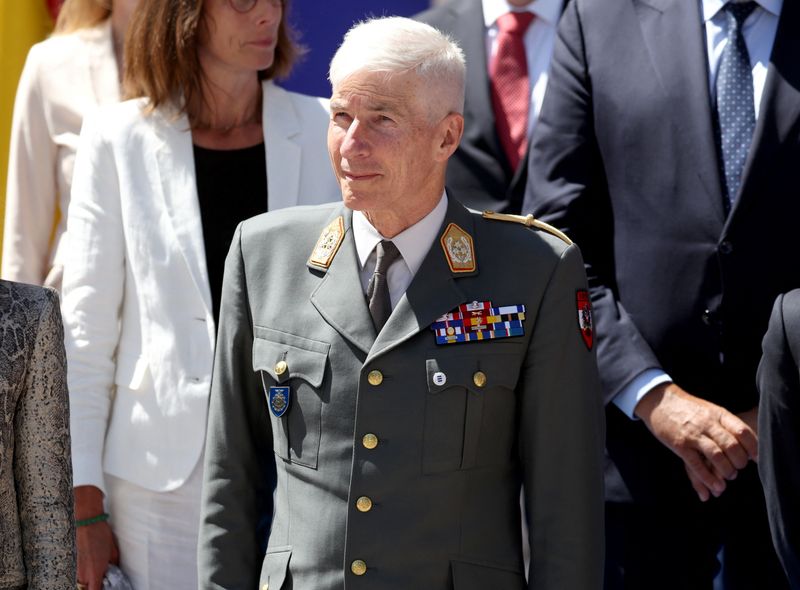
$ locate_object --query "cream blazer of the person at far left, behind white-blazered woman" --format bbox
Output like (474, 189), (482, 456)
(2, 20), (120, 288)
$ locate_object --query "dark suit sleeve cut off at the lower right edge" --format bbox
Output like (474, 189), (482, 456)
(758, 290), (800, 590)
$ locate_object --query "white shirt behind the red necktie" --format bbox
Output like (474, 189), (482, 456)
(483, 0), (564, 137)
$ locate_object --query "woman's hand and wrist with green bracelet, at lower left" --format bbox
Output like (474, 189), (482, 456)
(74, 486), (119, 590)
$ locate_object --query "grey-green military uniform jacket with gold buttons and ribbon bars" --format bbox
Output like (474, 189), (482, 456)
(199, 199), (603, 590)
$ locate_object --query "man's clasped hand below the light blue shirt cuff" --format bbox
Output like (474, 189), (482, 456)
(635, 383), (758, 502)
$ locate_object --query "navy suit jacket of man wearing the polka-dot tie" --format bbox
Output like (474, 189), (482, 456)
(524, 0), (800, 500)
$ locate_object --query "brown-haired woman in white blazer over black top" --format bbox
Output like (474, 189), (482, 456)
(63, 0), (339, 590)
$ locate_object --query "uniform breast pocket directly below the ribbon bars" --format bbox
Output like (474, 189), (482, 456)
(422, 352), (521, 474)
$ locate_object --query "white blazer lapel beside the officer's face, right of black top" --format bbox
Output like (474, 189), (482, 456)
(262, 82), (301, 211)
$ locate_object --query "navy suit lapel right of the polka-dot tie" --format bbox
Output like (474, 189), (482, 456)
(728, 0), (800, 224)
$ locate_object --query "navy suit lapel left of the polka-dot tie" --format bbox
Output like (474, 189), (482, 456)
(633, 0), (725, 221)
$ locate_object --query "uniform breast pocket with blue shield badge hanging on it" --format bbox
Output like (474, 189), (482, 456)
(253, 326), (330, 469)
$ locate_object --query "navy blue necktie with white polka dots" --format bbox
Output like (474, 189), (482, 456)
(717, 2), (756, 206)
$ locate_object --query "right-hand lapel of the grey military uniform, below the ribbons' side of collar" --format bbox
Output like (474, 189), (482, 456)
(367, 198), (480, 362)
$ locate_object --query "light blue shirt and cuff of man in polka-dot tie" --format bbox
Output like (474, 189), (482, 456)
(614, 0), (783, 419)
